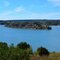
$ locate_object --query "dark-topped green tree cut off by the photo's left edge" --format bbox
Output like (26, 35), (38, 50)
(0, 42), (9, 60)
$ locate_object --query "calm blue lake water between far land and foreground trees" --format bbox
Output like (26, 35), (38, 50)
(0, 25), (60, 52)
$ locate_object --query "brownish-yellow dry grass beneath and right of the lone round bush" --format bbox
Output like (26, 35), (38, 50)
(30, 53), (60, 60)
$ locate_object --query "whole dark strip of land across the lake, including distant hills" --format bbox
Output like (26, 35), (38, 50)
(0, 19), (60, 30)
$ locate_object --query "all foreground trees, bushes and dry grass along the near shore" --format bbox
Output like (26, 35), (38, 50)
(0, 42), (60, 60)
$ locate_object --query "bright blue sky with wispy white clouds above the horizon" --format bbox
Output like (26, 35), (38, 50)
(0, 0), (60, 20)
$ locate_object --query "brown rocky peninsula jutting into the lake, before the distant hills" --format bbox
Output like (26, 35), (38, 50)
(5, 22), (51, 30)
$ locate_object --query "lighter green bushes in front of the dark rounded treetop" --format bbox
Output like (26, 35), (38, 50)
(8, 46), (30, 60)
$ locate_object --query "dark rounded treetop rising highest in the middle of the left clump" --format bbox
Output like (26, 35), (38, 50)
(17, 42), (33, 54)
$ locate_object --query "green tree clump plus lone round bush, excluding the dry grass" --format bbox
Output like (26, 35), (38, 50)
(0, 42), (49, 60)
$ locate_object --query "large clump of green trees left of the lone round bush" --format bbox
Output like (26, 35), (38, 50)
(0, 42), (32, 60)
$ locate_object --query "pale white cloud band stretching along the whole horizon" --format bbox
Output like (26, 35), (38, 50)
(0, 12), (60, 20)
